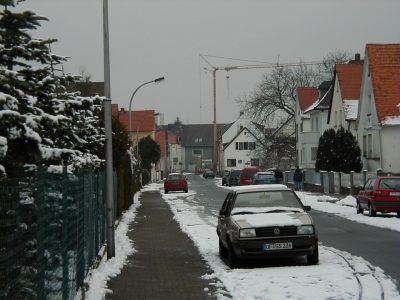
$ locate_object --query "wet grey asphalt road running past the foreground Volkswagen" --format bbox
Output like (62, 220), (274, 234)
(189, 175), (400, 291)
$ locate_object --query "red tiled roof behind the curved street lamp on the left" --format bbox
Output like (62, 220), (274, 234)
(119, 110), (155, 132)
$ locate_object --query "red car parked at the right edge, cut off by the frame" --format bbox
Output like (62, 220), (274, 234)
(357, 176), (400, 218)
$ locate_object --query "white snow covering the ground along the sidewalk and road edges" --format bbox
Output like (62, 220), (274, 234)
(77, 179), (400, 300)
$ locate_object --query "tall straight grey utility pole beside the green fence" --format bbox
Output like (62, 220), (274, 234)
(103, 0), (115, 259)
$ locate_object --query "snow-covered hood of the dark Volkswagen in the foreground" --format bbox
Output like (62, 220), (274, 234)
(231, 212), (313, 228)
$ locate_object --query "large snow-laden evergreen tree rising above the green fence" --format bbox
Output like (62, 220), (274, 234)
(0, 10), (104, 177)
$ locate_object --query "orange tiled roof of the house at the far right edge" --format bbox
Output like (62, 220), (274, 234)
(365, 44), (400, 122)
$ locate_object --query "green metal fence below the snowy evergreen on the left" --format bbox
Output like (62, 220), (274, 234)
(0, 168), (117, 299)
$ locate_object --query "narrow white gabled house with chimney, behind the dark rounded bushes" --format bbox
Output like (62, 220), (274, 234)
(328, 59), (363, 137)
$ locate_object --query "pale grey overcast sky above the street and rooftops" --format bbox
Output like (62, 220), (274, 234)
(12, 0), (400, 124)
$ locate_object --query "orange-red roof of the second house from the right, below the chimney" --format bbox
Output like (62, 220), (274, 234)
(336, 63), (364, 101)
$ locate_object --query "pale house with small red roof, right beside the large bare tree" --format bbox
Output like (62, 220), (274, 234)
(295, 81), (332, 169)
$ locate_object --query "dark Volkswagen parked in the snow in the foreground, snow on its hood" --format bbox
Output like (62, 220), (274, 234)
(217, 185), (319, 268)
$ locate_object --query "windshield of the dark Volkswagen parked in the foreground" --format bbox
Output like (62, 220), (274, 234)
(231, 191), (304, 215)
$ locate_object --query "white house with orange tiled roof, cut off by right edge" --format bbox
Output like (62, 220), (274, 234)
(356, 44), (400, 174)
